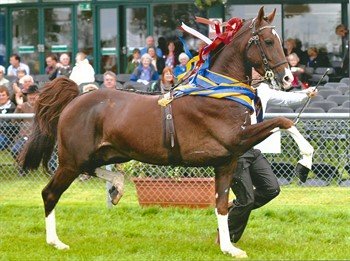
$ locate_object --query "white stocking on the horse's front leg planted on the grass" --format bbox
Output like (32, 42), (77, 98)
(215, 209), (248, 258)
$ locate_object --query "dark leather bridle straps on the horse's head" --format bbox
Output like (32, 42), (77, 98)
(246, 19), (288, 85)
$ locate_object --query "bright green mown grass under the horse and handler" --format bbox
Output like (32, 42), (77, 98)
(0, 181), (350, 260)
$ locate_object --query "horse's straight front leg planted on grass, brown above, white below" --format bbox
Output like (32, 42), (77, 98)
(215, 160), (247, 258)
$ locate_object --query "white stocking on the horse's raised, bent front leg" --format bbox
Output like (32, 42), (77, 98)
(286, 126), (314, 169)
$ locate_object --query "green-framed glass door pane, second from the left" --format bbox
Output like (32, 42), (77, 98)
(44, 7), (74, 64)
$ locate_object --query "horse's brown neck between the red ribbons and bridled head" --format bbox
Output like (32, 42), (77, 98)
(211, 46), (250, 81)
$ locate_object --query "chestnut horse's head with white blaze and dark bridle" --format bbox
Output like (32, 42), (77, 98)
(242, 7), (293, 89)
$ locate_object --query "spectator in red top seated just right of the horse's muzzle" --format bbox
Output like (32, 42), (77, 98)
(287, 53), (311, 89)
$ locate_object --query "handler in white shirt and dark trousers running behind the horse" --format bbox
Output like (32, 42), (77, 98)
(224, 69), (317, 243)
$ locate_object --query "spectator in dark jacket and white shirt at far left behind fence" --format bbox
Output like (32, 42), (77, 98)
(0, 86), (16, 150)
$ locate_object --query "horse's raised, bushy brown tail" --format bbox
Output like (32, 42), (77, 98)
(19, 77), (79, 170)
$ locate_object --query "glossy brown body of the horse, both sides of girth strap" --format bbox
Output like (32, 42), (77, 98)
(58, 85), (248, 172)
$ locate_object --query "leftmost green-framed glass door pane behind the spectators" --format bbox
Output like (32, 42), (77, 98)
(11, 9), (40, 74)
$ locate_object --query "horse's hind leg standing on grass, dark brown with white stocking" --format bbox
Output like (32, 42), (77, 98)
(41, 166), (79, 249)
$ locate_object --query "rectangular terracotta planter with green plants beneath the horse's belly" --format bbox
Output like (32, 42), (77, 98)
(124, 161), (215, 208)
